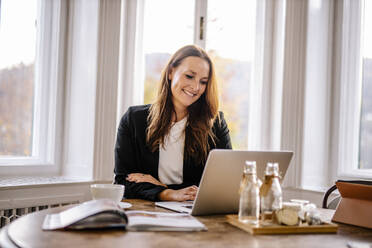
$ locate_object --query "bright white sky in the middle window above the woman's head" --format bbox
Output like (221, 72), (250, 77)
(143, 0), (256, 61)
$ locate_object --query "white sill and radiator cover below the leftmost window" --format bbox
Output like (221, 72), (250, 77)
(0, 176), (93, 228)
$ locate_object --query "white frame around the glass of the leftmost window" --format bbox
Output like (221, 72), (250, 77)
(0, 0), (67, 176)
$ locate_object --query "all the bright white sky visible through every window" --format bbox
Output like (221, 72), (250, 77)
(0, 0), (372, 69)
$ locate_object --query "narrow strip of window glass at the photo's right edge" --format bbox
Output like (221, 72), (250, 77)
(359, 0), (372, 169)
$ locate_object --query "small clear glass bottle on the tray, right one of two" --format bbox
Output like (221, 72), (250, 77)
(260, 163), (282, 215)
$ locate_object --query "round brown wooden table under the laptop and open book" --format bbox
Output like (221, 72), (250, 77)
(0, 200), (372, 248)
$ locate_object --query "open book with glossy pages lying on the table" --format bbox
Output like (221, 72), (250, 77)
(42, 200), (207, 231)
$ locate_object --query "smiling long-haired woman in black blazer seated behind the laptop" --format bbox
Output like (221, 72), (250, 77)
(115, 45), (231, 201)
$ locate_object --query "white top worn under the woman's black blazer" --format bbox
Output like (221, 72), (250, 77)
(158, 117), (187, 184)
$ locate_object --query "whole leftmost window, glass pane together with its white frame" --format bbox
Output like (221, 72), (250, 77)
(0, 0), (66, 172)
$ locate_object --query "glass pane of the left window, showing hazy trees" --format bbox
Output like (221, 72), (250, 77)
(0, 0), (37, 157)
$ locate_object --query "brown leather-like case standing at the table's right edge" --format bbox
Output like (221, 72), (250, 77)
(332, 181), (372, 228)
